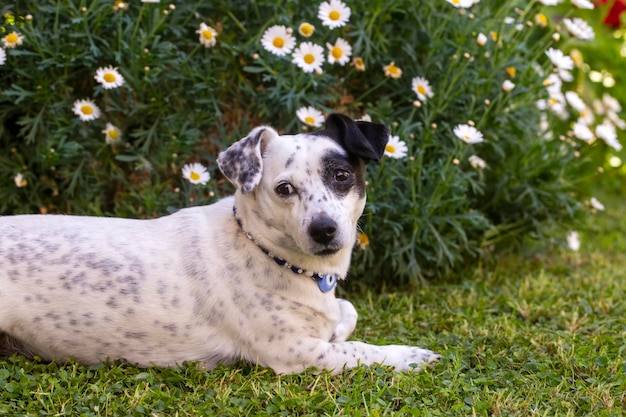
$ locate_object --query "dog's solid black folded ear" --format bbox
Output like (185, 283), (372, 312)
(314, 113), (389, 162)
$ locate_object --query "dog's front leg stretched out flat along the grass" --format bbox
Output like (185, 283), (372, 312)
(259, 338), (440, 374)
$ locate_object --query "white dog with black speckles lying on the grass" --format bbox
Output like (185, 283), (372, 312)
(0, 114), (439, 374)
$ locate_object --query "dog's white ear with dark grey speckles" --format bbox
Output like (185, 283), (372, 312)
(217, 126), (278, 194)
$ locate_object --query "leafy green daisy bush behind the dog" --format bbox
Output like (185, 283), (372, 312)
(0, 0), (619, 283)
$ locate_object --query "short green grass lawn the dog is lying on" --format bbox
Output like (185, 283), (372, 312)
(0, 189), (626, 416)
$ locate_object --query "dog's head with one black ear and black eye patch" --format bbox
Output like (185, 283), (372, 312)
(217, 114), (389, 273)
